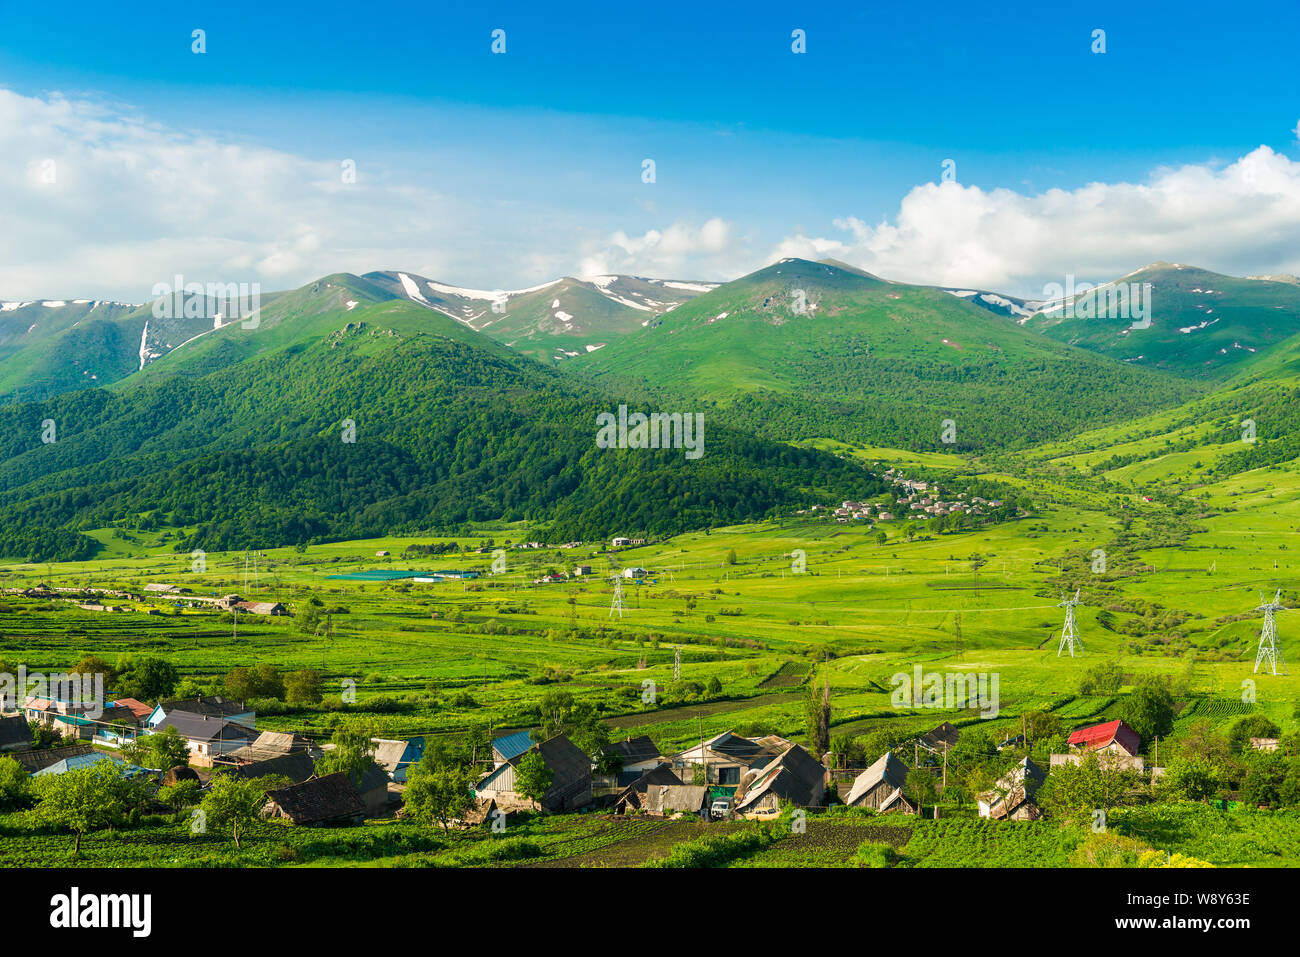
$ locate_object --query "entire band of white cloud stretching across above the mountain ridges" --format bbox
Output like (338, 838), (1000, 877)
(10, 88), (1300, 302)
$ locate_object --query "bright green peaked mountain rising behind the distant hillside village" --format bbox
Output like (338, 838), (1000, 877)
(566, 259), (1200, 449)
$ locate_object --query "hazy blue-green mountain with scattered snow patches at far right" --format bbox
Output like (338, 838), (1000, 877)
(1021, 263), (1300, 380)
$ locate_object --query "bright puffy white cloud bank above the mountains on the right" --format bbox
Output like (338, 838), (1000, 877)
(768, 146), (1300, 296)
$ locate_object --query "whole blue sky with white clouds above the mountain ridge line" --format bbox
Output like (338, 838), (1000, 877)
(0, 3), (1300, 298)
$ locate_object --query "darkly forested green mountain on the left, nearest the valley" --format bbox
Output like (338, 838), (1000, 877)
(0, 276), (884, 560)
